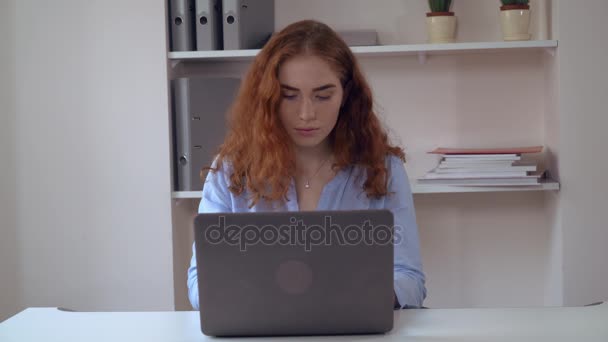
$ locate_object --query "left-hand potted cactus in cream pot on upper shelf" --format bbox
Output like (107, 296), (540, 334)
(426, 0), (456, 43)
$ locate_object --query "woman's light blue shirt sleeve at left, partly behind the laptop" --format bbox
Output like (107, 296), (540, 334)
(188, 163), (232, 310)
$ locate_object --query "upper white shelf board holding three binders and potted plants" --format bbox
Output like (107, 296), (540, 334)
(168, 40), (557, 62)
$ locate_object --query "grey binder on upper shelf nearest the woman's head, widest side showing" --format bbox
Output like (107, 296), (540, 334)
(222, 0), (274, 50)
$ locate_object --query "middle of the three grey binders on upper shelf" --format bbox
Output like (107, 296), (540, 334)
(195, 0), (224, 51)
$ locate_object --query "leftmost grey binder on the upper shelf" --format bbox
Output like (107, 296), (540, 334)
(169, 0), (195, 51)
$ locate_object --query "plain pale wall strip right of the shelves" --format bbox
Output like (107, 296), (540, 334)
(557, 0), (608, 305)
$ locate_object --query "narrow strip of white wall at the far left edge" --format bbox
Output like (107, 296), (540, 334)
(0, 0), (21, 321)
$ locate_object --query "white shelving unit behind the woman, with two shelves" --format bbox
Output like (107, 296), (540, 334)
(166, 0), (563, 310)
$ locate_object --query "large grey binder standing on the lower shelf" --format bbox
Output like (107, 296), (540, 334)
(172, 77), (240, 191)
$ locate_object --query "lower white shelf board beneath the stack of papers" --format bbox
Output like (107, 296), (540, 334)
(172, 179), (559, 199)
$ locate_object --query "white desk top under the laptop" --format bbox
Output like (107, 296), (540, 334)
(0, 303), (608, 342)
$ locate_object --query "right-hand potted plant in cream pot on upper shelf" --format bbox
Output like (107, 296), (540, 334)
(500, 0), (530, 41)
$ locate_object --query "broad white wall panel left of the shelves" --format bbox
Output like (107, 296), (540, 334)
(15, 0), (174, 310)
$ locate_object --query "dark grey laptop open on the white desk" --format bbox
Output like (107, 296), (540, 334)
(194, 210), (394, 336)
